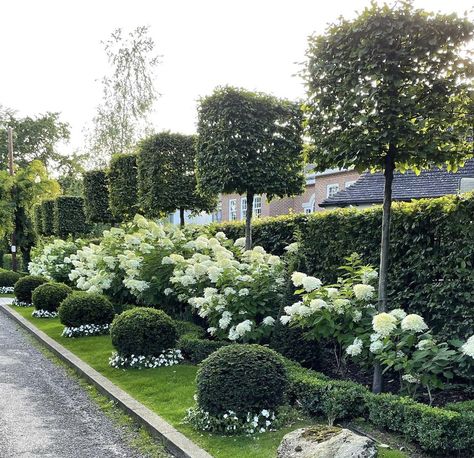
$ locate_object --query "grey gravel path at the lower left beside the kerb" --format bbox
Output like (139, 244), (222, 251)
(0, 299), (149, 458)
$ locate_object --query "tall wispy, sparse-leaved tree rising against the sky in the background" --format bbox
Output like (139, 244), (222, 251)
(89, 27), (158, 166)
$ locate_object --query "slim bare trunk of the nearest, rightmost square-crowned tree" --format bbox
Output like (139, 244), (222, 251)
(372, 151), (395, 393)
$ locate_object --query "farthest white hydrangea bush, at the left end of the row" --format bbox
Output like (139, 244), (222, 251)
(28, 239), (81, 281)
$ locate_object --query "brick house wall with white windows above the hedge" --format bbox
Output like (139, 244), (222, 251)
(220, 170), (360, 221)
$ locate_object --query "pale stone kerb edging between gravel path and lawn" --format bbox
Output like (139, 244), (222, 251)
(0, 303), (212, 458)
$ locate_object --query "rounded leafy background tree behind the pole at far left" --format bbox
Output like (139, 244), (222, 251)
(0, 106), (70, 171)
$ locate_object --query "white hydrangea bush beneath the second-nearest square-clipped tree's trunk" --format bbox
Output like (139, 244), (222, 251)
(168, 233), (285, 342)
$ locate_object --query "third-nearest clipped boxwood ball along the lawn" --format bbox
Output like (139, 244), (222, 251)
(58, 291), (115, 328)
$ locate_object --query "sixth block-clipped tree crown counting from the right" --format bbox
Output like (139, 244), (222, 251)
(54, 196), (89, 238)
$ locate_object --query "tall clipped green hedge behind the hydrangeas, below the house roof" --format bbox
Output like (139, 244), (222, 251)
(211, 193), (474, 338)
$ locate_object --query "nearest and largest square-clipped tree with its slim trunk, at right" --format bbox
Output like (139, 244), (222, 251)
(304, 2), (474, 392)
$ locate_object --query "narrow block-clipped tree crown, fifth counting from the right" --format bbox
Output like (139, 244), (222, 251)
(83, 170), (113, 223)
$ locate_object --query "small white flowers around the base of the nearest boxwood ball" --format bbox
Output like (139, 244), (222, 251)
(184, 407), (279, 436)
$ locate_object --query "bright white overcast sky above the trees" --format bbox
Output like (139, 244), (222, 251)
(0, 0), (473, 154)
